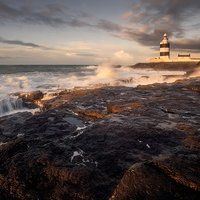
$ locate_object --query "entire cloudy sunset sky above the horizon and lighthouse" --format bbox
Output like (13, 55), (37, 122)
(0, 0), (200, 65)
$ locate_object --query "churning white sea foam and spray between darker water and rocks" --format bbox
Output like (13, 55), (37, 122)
(0, 64), (184, 96)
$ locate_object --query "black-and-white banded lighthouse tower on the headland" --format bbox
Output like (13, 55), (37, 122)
(160, 33), (170, 61)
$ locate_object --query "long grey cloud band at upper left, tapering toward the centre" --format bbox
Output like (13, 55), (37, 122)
(0, 2), (125, 32)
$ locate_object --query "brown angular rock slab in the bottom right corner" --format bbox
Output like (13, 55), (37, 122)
(110, 153), (200, 200)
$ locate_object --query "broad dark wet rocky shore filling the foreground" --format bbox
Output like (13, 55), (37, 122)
(0, 78), (200, 200)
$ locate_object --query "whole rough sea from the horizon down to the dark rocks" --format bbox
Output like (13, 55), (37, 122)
(0, 64), (185, 117)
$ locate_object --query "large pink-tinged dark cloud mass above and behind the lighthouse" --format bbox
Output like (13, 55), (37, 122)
(117, 0), (200, 49)
